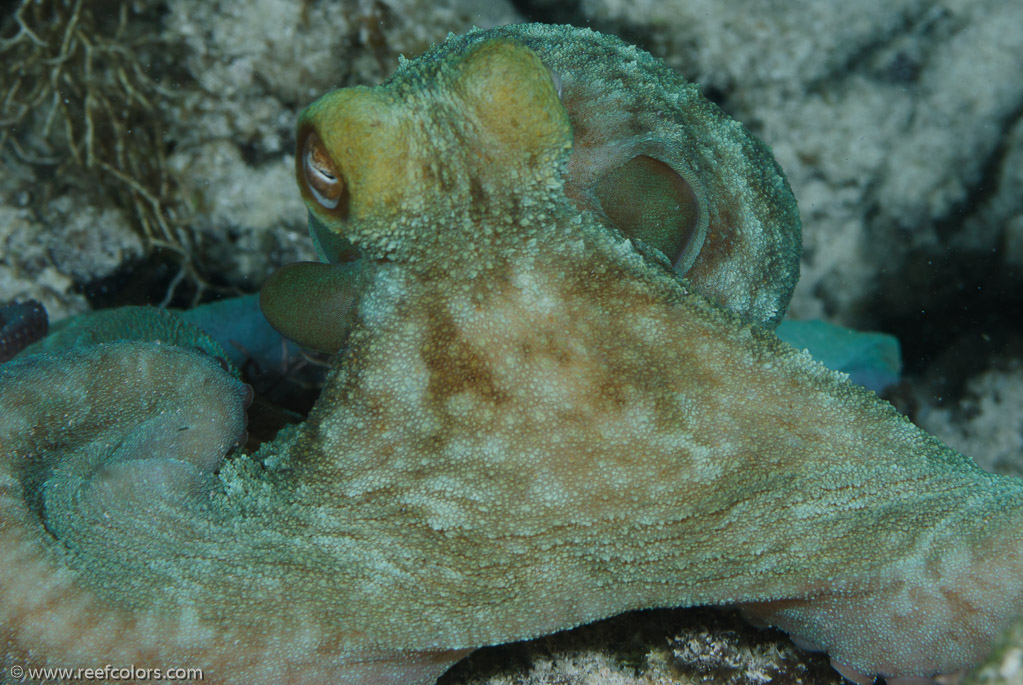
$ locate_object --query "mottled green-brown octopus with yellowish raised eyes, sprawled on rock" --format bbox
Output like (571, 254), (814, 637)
(0, 25), (1023, 685)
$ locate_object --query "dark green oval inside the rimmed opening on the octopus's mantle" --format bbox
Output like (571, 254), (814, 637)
(594, 154), (703, 271)
